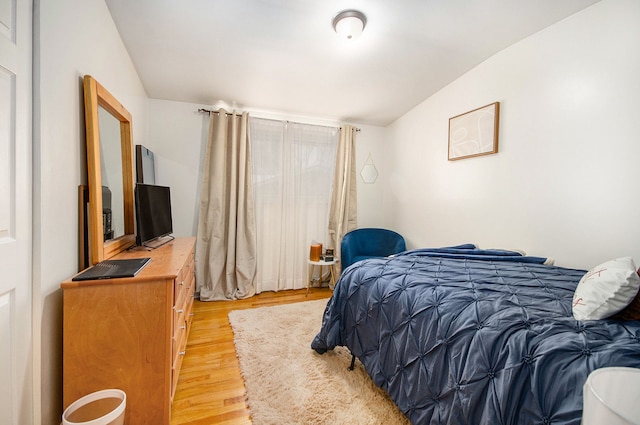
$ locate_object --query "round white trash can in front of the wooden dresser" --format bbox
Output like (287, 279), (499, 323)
(62, 389), (127, 425)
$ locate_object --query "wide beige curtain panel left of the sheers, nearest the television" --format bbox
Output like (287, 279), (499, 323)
(196, 109), (257, 301)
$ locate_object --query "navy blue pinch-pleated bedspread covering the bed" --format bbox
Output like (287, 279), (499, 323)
(311, 246), (640, 425)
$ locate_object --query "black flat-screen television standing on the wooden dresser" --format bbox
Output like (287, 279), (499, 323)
(135, 183), (173, 248)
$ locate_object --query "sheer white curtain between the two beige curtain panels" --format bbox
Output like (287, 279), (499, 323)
(249, 117), (338, 293)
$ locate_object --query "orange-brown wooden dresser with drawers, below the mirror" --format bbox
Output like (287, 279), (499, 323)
(61, 237), (195, 425)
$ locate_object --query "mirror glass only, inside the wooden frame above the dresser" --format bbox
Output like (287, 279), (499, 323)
(98, 106), (124, 238)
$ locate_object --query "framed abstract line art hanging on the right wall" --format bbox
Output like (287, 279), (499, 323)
(448, 102), (500, 161)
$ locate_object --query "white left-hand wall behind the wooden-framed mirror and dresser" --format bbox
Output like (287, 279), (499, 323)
(33, 0), (147, 425)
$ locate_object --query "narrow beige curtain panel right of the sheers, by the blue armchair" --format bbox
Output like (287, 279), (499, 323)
(329, 125), (358, 269)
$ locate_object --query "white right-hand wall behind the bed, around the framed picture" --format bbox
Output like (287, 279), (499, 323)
(384, 0), (640, 268)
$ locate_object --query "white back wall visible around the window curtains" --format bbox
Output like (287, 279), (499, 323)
(145, 99), (388, 236)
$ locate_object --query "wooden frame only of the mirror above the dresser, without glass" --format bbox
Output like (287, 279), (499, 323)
(84, 75), (136, 265)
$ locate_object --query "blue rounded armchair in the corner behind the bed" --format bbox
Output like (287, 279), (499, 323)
(340, 228), (407, 270)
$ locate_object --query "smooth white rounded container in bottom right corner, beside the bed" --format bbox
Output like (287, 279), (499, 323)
(582, 367), (640, 425)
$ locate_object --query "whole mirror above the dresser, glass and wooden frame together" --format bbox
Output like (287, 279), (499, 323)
(84, 75), (135, 265)
